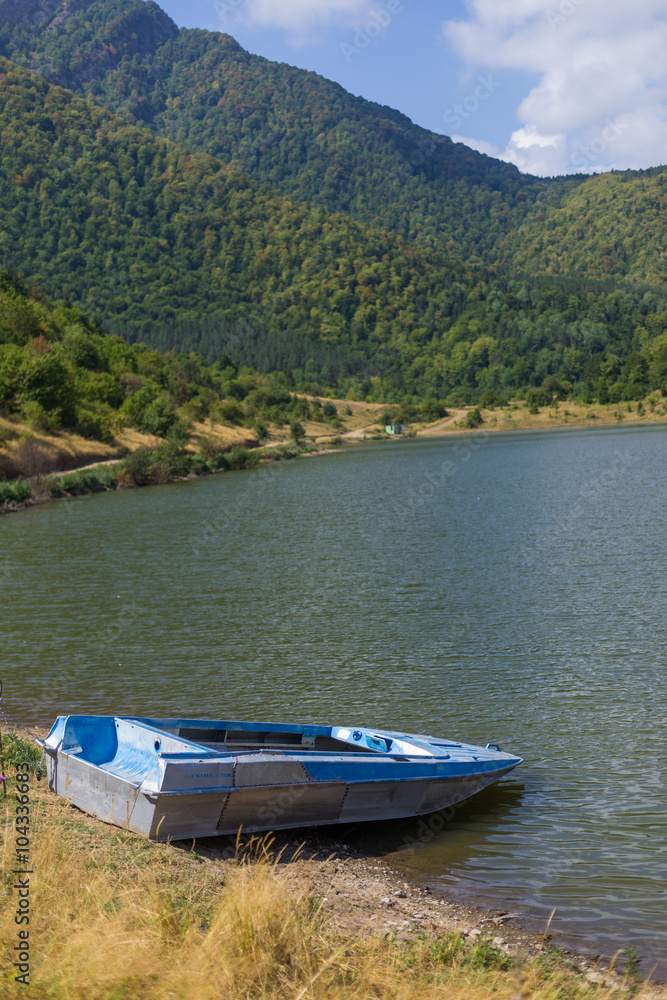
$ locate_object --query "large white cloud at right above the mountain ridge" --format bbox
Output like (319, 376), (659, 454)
(443, 0), (667, 175)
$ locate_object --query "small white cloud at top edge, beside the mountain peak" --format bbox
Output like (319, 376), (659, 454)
(216, 0), (374, 44)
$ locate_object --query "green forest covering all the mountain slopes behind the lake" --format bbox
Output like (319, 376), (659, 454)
(0, 0), (667, 425)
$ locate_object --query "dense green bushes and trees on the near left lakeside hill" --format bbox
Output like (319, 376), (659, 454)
(0, 262), (337, 460)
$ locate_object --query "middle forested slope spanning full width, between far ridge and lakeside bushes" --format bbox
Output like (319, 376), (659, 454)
(0, 59), (667, 401)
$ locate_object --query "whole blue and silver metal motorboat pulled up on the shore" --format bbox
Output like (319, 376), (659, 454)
(43, 715), (521, 841)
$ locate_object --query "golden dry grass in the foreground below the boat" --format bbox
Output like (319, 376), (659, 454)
(0, 782), (652, 1000)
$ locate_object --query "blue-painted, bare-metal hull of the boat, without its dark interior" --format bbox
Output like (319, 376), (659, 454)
(45, 717), (519, 841)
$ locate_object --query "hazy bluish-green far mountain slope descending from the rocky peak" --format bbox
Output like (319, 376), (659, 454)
(0, 0), (580, 261)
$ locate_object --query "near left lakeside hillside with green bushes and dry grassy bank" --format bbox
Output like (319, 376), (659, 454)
(0, 271), (410, 476)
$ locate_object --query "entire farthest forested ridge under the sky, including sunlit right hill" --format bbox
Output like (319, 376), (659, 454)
(0, 0), (667, 284)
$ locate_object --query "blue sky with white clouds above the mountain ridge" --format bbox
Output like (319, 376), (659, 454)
(158, 0), (667, 176)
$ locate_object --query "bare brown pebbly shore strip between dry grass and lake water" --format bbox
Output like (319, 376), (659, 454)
(3, 764), (667, 1000)
